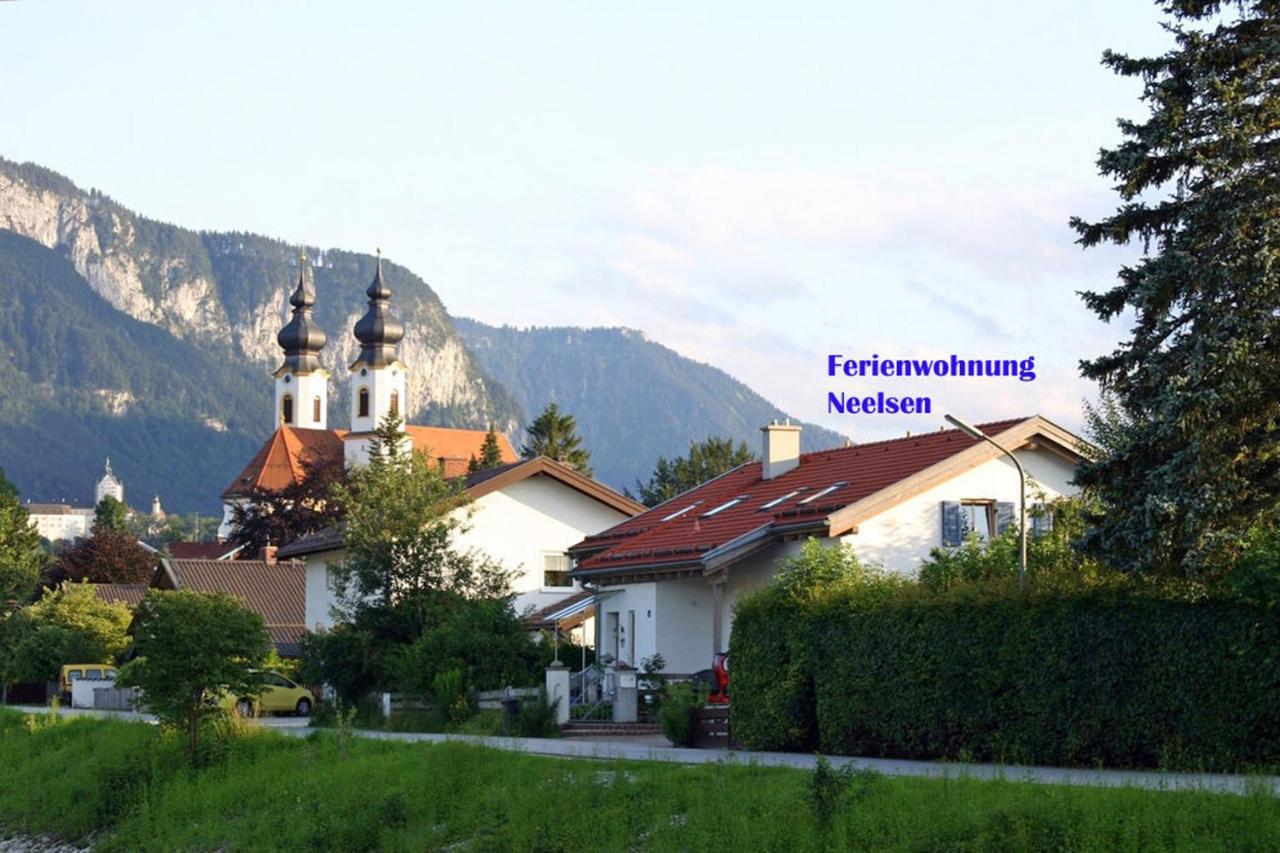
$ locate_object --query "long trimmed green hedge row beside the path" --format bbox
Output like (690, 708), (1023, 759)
(731, 583), (1280, 770)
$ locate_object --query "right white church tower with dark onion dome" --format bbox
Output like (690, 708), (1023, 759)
(344, 250), (410, 466)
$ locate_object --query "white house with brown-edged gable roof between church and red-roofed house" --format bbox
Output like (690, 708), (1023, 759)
(279, 457), (644, 630)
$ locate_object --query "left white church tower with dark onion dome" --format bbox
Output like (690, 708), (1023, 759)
(273, 256), (329, 429)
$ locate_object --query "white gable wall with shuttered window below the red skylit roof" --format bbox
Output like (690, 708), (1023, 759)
(845, 450), (1079, 573)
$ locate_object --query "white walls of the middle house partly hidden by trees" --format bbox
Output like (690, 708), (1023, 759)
(305, 475), (630, 630)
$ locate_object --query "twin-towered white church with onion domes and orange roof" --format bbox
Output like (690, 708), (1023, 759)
(218, 252), (518, 539)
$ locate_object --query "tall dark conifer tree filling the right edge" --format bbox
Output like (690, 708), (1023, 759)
(1071, 0), (1280, 575)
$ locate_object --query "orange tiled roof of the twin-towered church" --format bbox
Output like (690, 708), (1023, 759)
(223, 424), (520, 498)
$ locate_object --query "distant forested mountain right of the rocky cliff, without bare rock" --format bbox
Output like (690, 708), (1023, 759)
(453, 318), (845, 491)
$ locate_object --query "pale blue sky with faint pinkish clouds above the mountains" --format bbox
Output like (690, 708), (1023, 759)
(0, 0), (1169, 441)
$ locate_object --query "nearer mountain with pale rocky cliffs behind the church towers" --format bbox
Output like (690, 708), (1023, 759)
(0, 159), (521, 514)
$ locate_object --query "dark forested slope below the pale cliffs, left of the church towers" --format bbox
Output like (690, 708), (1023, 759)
(0, 225), (263, 514)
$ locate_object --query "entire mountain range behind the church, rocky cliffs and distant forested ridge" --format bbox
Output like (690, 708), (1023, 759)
(0, 158), (842, 514)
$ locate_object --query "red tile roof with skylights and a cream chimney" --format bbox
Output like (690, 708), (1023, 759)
(570, 419), (1054, 579)
